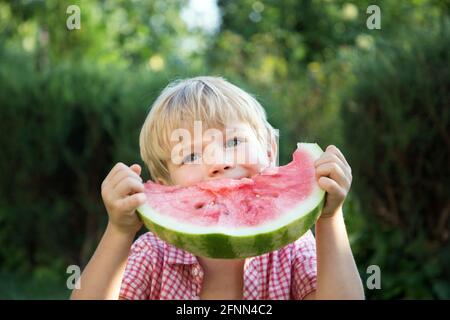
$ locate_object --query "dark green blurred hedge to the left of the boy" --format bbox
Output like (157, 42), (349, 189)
(0, 47), (167, 272)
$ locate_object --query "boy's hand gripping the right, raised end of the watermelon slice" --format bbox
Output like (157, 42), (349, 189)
(314, 146), (352, 218)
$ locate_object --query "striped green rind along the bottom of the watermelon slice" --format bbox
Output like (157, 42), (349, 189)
(137, 143), (325, 259)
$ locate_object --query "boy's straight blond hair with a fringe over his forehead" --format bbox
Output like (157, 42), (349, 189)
(139, 76), (278, 182)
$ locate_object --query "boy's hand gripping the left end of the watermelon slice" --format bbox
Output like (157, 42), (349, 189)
(102, 162), (146, 233)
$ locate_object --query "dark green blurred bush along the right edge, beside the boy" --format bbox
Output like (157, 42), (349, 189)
(342, 20), (450, 299)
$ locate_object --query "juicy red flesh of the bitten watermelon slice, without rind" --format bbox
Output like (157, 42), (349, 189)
(145, 144), (315, 228)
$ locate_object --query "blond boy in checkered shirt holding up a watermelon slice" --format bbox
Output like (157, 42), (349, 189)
(72, 77), (364, 299)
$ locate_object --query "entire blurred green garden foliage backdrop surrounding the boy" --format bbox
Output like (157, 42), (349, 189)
(0, 0), (450, 299)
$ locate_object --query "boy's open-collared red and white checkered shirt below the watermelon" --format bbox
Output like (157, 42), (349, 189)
(120, 231), (317, 300)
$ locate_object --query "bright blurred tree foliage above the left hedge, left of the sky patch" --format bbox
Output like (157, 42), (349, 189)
(0, 0), (200, 69)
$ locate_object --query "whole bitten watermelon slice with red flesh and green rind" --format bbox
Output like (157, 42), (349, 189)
(137, 143), (325, 259)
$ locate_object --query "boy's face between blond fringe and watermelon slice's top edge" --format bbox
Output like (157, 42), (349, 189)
(163, 122), (275, 186)
